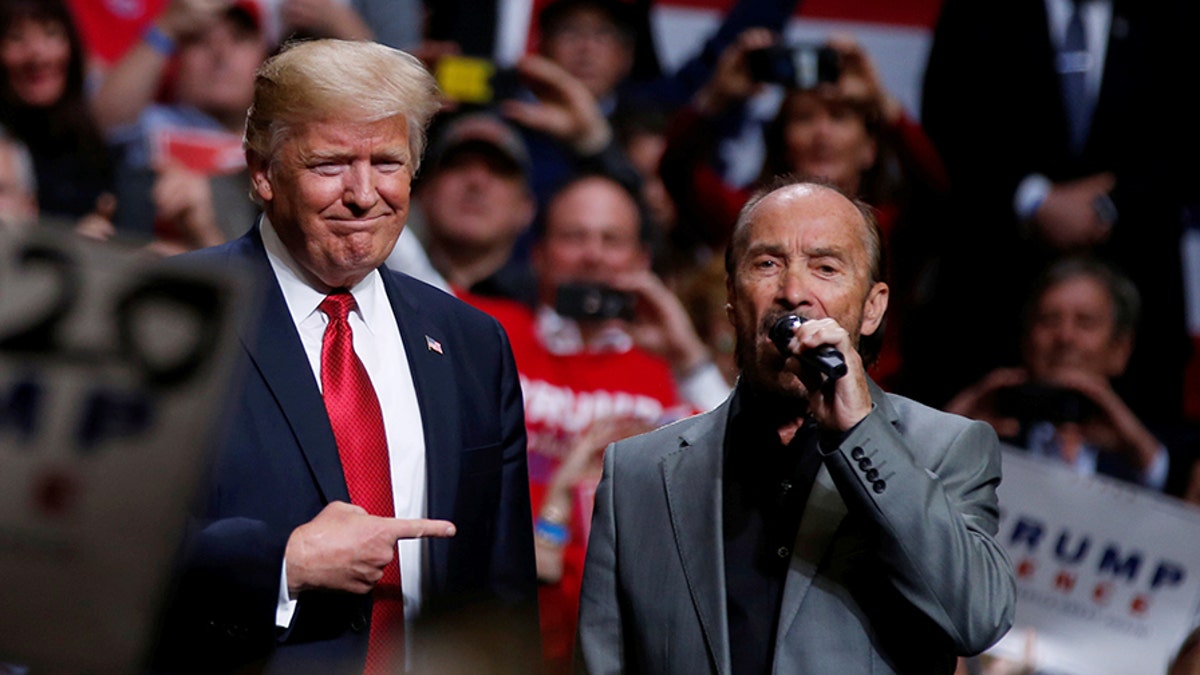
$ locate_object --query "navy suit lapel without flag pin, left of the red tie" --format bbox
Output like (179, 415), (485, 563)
(236, 227), (350, 503)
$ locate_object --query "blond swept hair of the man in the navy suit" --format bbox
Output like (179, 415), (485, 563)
(244, 40), (439, 173)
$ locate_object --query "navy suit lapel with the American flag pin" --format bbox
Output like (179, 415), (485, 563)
(379, 269), (462, 584)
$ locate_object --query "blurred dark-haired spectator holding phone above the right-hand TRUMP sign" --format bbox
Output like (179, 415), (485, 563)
(946, 258), (1169, 490)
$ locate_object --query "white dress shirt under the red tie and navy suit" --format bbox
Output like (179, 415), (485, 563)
(260, 216), (426, 627)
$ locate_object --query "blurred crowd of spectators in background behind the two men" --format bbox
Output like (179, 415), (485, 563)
(0, 0), (1200, 669)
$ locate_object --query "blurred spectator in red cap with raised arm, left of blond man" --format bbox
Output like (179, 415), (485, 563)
(94, 0), (268, 250)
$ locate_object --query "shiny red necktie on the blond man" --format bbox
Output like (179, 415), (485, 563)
(320, 292), (404, 675)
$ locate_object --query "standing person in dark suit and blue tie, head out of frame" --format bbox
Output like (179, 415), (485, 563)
(906, 0), (1200, 422)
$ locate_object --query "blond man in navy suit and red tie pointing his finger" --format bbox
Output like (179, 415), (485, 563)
(157, 40), (536, 673)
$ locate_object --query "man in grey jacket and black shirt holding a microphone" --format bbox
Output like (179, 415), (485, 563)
(578, 181), (1015, 675)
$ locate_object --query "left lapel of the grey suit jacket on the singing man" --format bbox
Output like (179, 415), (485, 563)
(661, 400), (731, 673)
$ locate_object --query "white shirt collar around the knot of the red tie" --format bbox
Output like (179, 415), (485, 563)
(259, 215), (386, 333)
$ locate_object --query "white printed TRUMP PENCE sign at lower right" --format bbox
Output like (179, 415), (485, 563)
(992, 448), (1200, 675)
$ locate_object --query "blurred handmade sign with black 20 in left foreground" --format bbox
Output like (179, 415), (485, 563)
(0, 227), (245, 673)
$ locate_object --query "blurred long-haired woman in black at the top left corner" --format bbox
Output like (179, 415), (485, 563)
(0, 0), (113, 221)
